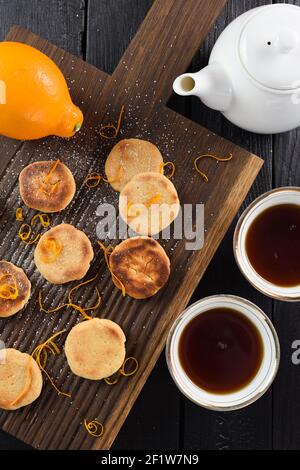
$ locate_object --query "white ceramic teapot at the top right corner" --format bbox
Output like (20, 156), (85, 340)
(173, 3), (300, 134)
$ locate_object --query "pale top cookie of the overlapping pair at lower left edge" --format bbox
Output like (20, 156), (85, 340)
(0, 348), (31, 408)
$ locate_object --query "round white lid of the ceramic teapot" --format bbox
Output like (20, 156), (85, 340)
(239, 4), (300, 90)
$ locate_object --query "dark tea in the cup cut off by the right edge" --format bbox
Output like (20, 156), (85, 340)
(246, 204), (300, 287)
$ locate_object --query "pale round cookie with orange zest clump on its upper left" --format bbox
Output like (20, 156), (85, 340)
(34, 224), (94, 284)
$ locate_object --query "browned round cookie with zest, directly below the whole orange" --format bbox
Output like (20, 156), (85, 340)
(19, 160), (76, 212)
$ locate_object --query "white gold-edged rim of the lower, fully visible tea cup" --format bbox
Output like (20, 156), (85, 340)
(166, 294), (280, 411)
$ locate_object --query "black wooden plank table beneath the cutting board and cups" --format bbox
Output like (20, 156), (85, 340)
(0, 0), (300, 449)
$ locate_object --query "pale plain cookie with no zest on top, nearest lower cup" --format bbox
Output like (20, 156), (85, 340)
(65, 318), (126, 380)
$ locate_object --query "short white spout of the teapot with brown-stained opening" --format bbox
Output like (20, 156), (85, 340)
(173, 63), (232, 112)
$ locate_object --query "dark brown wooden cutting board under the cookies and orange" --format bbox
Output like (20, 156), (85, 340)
(0, 0), (263, 449)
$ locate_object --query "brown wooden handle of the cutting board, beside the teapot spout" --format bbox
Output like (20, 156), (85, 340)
(113, 0), (227, 105)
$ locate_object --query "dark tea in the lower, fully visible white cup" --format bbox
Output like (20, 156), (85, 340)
(179, 308), (263, 394)
